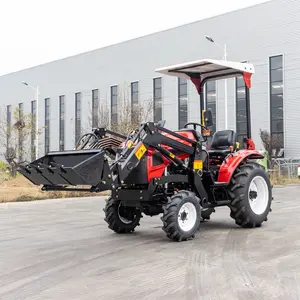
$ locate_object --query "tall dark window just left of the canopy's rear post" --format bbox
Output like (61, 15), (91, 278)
(235, 77), (248, 147)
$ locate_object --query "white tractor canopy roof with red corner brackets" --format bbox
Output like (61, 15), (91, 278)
(155, 59), (255, 94)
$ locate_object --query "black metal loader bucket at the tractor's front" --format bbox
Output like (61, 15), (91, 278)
(18, 149), (108, 186)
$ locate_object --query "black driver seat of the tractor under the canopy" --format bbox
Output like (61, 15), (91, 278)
(208, 130), (237, 156)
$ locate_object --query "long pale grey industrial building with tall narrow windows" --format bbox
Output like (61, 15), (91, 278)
(0, 0), (300, 162)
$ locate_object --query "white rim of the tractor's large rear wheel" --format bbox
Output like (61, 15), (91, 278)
(248, 176), (269, 215)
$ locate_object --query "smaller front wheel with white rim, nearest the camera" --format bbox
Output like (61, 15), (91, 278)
(161, 191), (201, 242)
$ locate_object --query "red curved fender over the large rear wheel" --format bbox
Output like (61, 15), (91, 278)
(218, 150), (264, 183)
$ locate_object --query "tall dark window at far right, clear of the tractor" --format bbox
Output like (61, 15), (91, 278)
(270, 55), (284, 154)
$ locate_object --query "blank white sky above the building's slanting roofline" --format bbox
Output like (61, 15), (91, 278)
(0, 0), (267, 75)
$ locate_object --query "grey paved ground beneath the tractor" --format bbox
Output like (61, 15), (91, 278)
(0, 187), (300, 300)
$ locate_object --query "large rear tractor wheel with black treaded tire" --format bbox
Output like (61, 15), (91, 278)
(228, 161), (273, 228)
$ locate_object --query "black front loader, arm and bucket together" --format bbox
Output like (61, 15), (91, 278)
(19, 122), (207, 202)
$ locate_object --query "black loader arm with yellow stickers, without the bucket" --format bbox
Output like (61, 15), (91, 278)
(93, 122), (207, 199)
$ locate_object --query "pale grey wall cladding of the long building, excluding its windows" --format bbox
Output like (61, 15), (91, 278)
(0, 0), (300, 157)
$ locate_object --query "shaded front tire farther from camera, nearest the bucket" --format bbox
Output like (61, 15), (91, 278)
(103, 197), (141, 233)
